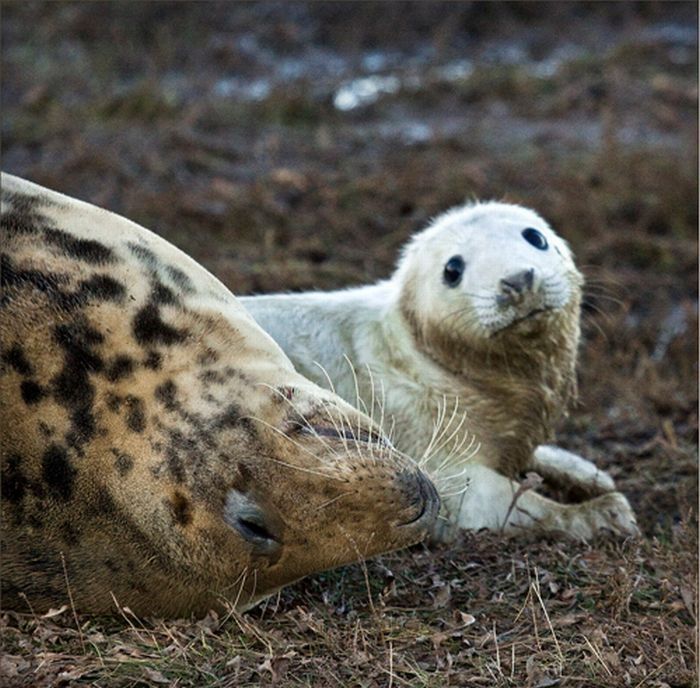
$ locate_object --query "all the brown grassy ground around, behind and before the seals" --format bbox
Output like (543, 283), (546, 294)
(0, 2), (698, 688)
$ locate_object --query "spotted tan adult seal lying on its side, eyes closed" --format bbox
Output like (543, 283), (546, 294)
(0, 175), (438, 616)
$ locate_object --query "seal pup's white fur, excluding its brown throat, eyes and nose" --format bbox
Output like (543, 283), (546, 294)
(240, 203), (636, 539)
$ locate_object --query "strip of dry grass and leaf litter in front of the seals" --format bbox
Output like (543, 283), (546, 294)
(3, 527), (697, 688)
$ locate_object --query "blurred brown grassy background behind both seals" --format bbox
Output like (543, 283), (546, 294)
(2, 2), (698, 532)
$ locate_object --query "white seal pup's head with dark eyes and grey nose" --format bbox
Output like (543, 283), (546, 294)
(395, 202), (583, 367)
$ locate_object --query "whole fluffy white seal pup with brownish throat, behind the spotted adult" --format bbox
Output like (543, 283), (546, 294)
(242, 203), (636, 539)
